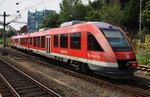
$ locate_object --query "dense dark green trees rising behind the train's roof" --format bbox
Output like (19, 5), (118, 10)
(40, 0), (150, 35)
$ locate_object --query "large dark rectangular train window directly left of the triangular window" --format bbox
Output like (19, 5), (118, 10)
(70, 32), (81, 49)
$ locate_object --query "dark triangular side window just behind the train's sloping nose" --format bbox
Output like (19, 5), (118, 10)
(87, 32), (103, 51)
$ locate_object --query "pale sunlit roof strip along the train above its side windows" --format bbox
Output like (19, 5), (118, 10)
(10, 22), (118, 38)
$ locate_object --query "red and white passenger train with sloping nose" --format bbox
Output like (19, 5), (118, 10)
(11, 22), (138, 79)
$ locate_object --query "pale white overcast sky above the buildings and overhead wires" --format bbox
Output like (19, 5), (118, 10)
(0, 0), (91, 30)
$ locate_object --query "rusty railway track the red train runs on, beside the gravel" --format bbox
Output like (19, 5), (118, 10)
(0, 48), (150, 97)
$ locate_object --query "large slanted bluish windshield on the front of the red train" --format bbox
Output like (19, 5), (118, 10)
(101, 29), (132, 52)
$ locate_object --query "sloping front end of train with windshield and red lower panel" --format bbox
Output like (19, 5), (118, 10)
(93, 24), (138, 79)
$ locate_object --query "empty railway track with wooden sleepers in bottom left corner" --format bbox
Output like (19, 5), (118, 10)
(0, 59), (61, 97)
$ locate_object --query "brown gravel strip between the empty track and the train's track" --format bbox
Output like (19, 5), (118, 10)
(0, 46), (135, 97)
